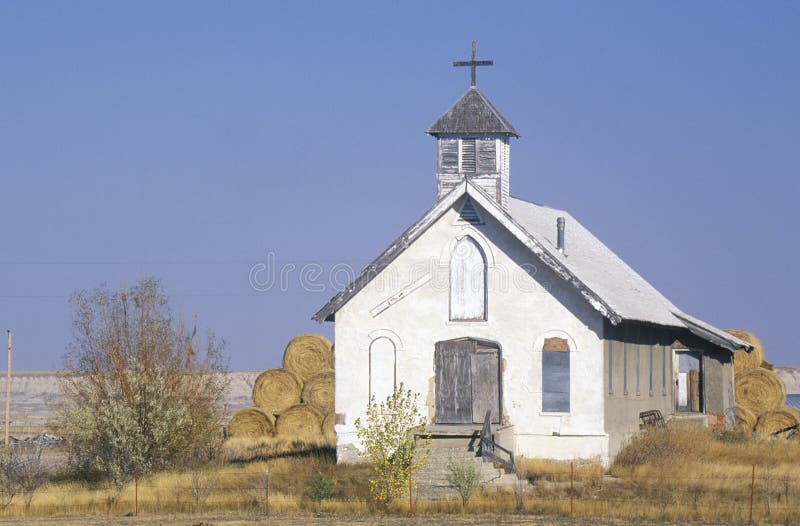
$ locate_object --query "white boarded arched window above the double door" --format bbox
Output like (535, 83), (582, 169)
(450, 236), (486, 321)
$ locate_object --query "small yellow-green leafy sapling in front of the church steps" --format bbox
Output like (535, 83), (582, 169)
(355, 383), (429, 510)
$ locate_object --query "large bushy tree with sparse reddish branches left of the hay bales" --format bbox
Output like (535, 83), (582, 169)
(54, 278), (227, 489)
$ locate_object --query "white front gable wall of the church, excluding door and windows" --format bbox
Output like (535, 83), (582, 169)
(335, 198), (608, 461)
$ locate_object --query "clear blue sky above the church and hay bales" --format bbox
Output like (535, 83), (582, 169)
(0, 1), (800, 370)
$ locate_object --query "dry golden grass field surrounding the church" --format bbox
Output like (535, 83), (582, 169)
(0, 427), (800, 524)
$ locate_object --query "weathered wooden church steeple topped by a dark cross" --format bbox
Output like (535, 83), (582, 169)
(428, 41), (519, 209)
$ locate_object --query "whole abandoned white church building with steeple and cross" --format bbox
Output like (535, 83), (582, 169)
(314, 46), (751, 463)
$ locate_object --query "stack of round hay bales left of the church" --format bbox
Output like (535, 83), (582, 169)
(228, 334), (334, 444)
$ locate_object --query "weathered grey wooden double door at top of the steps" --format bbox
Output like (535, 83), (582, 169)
(434, 338), (501, 424)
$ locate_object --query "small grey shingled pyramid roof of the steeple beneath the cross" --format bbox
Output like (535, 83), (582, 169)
(428, 86), (519, 137)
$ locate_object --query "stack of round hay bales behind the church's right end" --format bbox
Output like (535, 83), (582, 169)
(727, 329), (800, 435)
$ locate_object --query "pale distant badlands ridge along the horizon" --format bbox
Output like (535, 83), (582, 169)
(0, 367), (800, 435)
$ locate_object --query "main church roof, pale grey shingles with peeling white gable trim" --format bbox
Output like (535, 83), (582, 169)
(314, 182), (752, 351)
